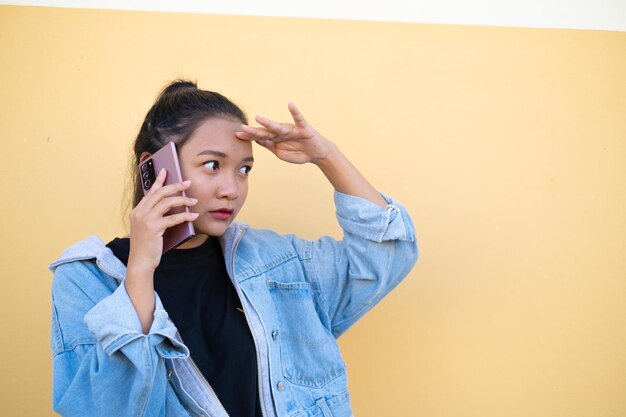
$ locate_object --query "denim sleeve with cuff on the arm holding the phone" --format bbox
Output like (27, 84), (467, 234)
(51, 261), (189, 417)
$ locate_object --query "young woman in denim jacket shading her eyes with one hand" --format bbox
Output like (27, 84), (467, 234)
(50, 81), (417, 417)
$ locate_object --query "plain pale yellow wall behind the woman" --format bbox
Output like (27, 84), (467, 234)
(0, 7), (626, 417)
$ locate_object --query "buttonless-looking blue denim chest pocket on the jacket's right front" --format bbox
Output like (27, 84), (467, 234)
(267, 281), (346, 388)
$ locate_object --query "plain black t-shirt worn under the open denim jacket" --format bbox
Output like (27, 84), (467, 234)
(107, 237), (262, 417)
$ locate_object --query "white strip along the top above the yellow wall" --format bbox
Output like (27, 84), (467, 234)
(0, 0), (626, 31)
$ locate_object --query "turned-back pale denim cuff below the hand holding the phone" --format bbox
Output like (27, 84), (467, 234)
(85, 282), (189, 358)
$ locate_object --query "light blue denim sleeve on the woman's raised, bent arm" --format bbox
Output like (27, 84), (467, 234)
(294, 192), (418, 337)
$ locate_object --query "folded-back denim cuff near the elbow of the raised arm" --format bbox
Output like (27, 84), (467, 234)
(334, 191), (415, 242)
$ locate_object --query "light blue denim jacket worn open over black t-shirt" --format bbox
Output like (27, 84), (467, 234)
(50, 193), (417, 417)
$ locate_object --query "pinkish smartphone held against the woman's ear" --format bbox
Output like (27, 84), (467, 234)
(139, 142), (196, 253)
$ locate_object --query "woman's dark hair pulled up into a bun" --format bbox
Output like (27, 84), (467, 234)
(131, 80), (248, 207)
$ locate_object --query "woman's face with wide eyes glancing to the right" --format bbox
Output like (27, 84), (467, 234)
(178, 117), (254, 240)
